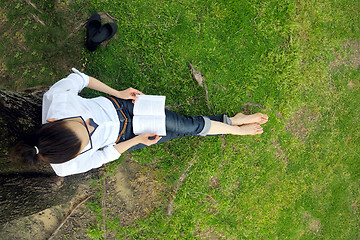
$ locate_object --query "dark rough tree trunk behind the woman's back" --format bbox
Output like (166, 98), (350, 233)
(0, 90), (98, 224)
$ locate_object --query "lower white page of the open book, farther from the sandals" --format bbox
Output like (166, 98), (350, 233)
(133, 115), (166, 136)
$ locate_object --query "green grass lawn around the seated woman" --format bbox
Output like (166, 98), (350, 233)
(0, 0), (360, 239)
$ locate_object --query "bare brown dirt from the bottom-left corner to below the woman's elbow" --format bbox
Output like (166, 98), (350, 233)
(0, 155), (165, 240)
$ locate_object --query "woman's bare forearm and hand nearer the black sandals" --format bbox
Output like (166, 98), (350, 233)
(87, 77), (143, 100)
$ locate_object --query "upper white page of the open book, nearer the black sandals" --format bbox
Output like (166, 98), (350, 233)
(134, 95), (166, 116)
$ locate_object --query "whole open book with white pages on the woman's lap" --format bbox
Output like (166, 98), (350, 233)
(133, 95), (166, 136)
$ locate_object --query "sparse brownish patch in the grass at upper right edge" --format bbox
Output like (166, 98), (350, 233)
(330, 40), (360, 69)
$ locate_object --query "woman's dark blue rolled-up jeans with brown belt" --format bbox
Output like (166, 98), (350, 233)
(106, 97), (229, 151)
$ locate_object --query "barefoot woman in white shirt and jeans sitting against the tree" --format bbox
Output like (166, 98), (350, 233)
(13, 69), (268, 176)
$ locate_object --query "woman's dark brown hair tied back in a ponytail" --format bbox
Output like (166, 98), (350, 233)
(11, 121), (81, 165)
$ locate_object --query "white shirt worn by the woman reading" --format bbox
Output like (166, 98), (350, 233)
(42, 68), (120, 177)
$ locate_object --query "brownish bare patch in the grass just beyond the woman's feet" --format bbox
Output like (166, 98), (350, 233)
(285, 107), (320, 141)
